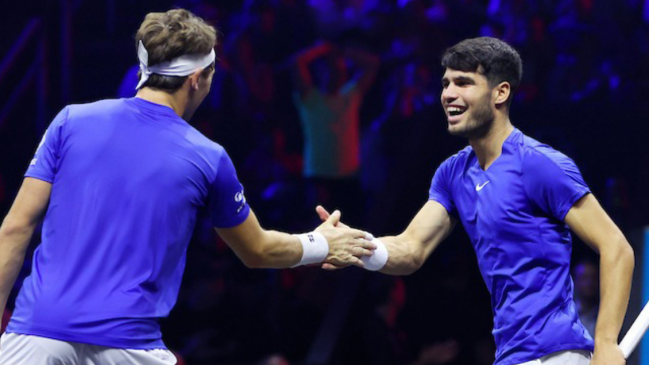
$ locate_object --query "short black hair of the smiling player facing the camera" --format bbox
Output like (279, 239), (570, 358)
(442, 37), (523, 105)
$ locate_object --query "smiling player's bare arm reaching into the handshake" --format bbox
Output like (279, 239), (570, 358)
(316, 200), (455, 275)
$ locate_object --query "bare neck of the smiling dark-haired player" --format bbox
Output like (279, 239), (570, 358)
(469, 115), (514, 170)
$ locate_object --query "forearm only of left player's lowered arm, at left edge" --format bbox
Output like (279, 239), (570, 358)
(0, 224), (34, 311)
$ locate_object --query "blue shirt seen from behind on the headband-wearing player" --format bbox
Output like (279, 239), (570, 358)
(7, 98), (249, 349)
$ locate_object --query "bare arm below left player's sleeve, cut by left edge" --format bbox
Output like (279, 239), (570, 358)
(0, 177), (52, 318)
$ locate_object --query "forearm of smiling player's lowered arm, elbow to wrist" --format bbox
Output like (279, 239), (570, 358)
(595, 237), (634, 347)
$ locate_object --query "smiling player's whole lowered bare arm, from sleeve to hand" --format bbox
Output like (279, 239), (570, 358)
(565, 194), (634, 365)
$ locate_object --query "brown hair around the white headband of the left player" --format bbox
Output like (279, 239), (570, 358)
(135, 9), (217, 93)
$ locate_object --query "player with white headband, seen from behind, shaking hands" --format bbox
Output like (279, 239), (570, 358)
(0, 9), (374, 365)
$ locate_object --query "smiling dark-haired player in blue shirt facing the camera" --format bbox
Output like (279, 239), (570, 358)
(317, 38), (634, 365)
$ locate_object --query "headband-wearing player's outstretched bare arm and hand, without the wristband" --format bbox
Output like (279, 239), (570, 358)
(216, 210), (374, 268)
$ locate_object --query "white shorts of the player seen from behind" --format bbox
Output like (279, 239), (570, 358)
(0, 333), (176, 365)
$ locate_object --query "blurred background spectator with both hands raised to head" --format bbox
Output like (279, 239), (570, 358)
(294, 42), (379, 225)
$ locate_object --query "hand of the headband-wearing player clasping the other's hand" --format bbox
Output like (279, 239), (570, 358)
(315, 210), (376, 268)
